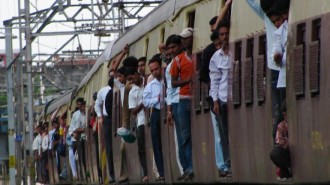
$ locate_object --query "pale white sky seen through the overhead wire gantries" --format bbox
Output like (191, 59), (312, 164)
(0, 0), (155, 60)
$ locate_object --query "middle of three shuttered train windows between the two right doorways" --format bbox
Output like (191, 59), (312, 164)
(244, 38), (254, 106)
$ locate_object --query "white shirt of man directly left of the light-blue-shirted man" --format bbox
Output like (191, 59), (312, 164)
(128, 84), (145, 127)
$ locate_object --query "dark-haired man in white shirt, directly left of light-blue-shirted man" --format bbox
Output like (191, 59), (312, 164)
(126, 67), (148, 182)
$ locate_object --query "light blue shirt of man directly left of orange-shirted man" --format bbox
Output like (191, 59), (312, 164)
(143, 78), (163, 109)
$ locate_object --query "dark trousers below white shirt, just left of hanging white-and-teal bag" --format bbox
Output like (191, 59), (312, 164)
(103, 116), (115, 179)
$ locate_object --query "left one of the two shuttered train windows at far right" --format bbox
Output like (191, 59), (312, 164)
(294, 23), (306, 98)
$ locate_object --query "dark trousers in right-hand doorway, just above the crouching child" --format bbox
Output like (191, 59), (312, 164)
(271, 70), (285, 145)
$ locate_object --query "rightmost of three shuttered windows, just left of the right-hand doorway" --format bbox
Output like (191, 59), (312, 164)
(257, 34), (267, 105)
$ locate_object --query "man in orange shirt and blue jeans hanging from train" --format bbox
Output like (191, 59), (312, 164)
(166, 35), (194, 181)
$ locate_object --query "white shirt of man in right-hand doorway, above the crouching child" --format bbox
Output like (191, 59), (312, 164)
(272, 21), (288, 88)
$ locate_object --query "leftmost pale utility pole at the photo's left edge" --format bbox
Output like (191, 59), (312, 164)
(4, 21), (16, 185)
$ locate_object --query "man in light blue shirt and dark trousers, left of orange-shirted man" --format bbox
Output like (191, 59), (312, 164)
(143, 56), (165, 181)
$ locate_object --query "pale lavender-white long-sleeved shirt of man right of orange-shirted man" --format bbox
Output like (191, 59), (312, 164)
(209, 49), (233, 102)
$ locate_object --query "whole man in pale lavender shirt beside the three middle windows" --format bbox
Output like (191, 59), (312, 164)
(209, 21), (233, 177)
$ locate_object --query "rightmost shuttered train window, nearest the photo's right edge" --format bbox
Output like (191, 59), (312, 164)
(309, 19), (321, 96)
